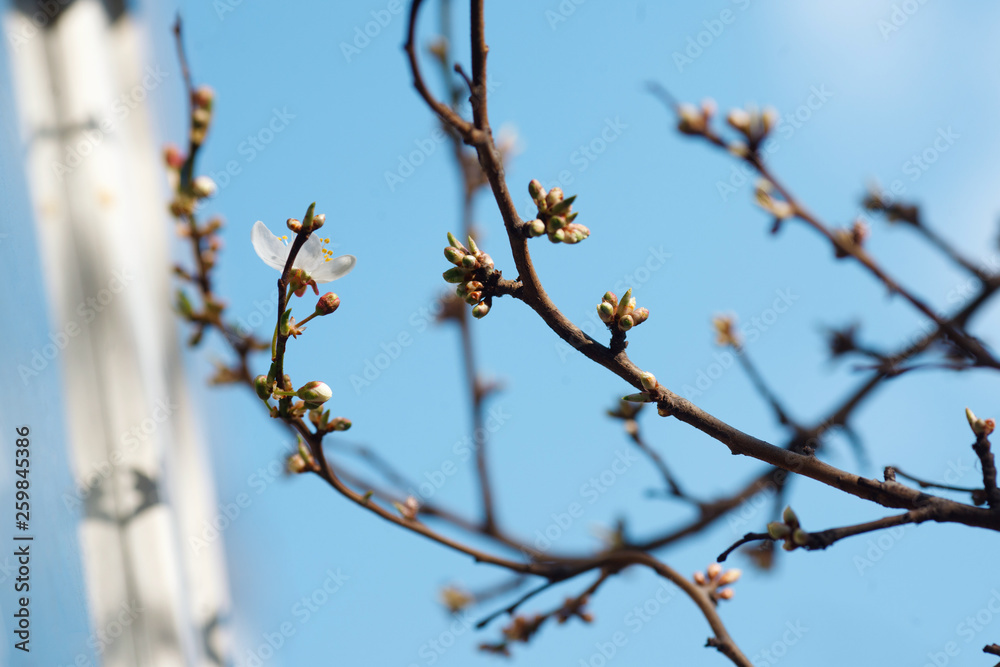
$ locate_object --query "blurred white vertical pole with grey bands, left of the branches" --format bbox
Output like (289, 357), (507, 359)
(4, 0), (229, 667)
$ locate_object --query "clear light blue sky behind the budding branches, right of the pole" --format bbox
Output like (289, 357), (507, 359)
(5, 0), (1000, 667)
